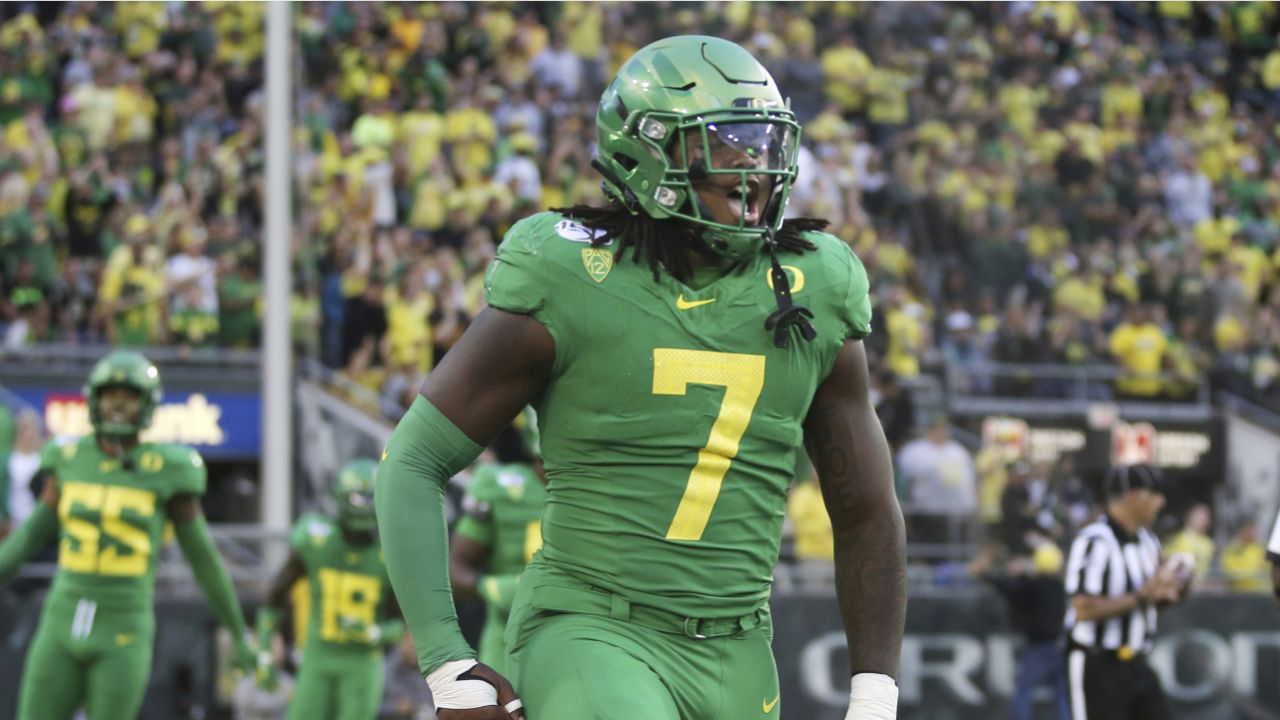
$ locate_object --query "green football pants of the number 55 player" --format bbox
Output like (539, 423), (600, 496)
(18, 598), (155, 720)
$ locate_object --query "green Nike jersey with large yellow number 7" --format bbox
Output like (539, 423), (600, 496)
(485, 213), (870, 618)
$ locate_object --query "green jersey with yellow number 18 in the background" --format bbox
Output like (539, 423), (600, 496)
(289, 515), (392, 656)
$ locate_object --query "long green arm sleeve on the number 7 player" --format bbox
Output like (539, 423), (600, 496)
(374, 396), (483, 675)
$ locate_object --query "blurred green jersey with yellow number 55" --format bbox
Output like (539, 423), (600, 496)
(41, 434), (206, 610)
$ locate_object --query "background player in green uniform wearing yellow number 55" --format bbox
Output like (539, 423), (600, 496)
(0, 351), (253, 720)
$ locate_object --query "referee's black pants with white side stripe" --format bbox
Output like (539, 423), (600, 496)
(1066, 647), (1170, 720)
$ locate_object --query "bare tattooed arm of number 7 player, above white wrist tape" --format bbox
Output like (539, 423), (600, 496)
(804, 340), (906, 678)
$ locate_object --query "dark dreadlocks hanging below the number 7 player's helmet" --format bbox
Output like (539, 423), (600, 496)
(550, 199), (829, 282)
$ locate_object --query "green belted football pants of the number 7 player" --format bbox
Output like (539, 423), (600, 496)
(507, 570), (782, 720)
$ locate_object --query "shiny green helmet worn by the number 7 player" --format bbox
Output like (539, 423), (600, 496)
(595, 35), (800, 260)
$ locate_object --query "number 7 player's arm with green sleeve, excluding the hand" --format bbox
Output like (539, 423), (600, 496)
(374, 307), (556, 674)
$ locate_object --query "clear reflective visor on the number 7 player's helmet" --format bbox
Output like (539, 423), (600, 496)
(685, 122), (796, 172)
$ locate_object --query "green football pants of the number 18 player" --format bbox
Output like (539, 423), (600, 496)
(288, 643), (384, 720)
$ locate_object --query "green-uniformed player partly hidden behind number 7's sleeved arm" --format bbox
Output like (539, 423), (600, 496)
(449, 413), (547, 673)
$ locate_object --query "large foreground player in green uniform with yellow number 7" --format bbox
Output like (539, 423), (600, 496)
(376, 36), (905, 720)
